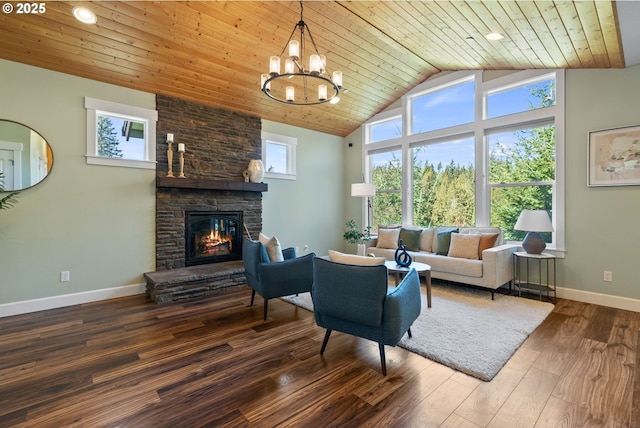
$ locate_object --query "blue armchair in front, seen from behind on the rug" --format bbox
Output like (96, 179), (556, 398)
(311, 258), (421, 376)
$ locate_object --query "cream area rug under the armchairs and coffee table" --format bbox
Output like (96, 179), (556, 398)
(283, 283), (553, 381)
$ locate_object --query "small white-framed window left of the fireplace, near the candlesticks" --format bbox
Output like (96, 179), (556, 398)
(84, 97), (158, 169)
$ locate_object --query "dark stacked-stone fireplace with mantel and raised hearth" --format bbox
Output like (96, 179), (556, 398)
(145, 95), (267, 303)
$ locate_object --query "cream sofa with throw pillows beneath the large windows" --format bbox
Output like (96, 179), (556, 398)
(366, 226), (518, 299)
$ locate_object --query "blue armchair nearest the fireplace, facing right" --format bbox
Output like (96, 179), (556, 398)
(242, 238), (315, 320)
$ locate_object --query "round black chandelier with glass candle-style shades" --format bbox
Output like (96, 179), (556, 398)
(261, 2), (342, 105)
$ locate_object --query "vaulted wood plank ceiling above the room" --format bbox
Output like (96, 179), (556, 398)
(0, 0), (624, 136)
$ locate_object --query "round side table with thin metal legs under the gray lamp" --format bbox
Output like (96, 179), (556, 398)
(513, 251), (556, 303)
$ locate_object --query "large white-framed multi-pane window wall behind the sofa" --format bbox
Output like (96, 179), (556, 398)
(364, 71), (564, 250)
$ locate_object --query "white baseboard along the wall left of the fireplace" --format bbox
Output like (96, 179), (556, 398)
(0, 284), (146, 318)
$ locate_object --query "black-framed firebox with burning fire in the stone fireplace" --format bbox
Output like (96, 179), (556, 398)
(184, 211), (242, 266)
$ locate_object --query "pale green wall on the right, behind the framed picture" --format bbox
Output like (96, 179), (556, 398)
(558, 65), (640, 299)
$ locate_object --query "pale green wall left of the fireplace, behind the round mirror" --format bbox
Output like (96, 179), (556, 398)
(0, 60), (155, 303)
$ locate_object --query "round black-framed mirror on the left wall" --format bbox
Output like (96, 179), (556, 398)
(0, 120), (53, 192)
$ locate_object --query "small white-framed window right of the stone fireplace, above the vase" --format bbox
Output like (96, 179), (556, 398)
(262, 132), (298, 180)
